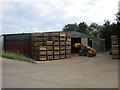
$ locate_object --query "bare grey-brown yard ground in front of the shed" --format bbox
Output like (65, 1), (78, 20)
(2, 52), (118, 88)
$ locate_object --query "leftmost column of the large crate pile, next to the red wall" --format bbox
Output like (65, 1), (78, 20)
(32, 33), (47, 60)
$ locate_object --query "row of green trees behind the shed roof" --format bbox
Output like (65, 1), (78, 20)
(63, 18), (120, 50)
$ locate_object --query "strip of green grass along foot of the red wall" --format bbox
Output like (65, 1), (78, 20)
(0, 53), (37, 64)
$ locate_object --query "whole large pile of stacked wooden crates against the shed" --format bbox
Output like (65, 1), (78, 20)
(31, 32), (71, 60)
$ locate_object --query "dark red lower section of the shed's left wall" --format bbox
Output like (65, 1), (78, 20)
(5, 40), (31, 57)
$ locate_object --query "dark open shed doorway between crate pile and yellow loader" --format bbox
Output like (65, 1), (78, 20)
(71, 37), (81, 53)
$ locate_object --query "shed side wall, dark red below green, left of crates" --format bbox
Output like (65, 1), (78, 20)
(4, 34), (31, 57)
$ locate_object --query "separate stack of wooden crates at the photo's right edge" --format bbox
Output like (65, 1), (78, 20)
(111, 35), (120, 59)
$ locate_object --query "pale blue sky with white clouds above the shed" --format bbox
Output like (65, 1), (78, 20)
(0, 0), (119, 33)
